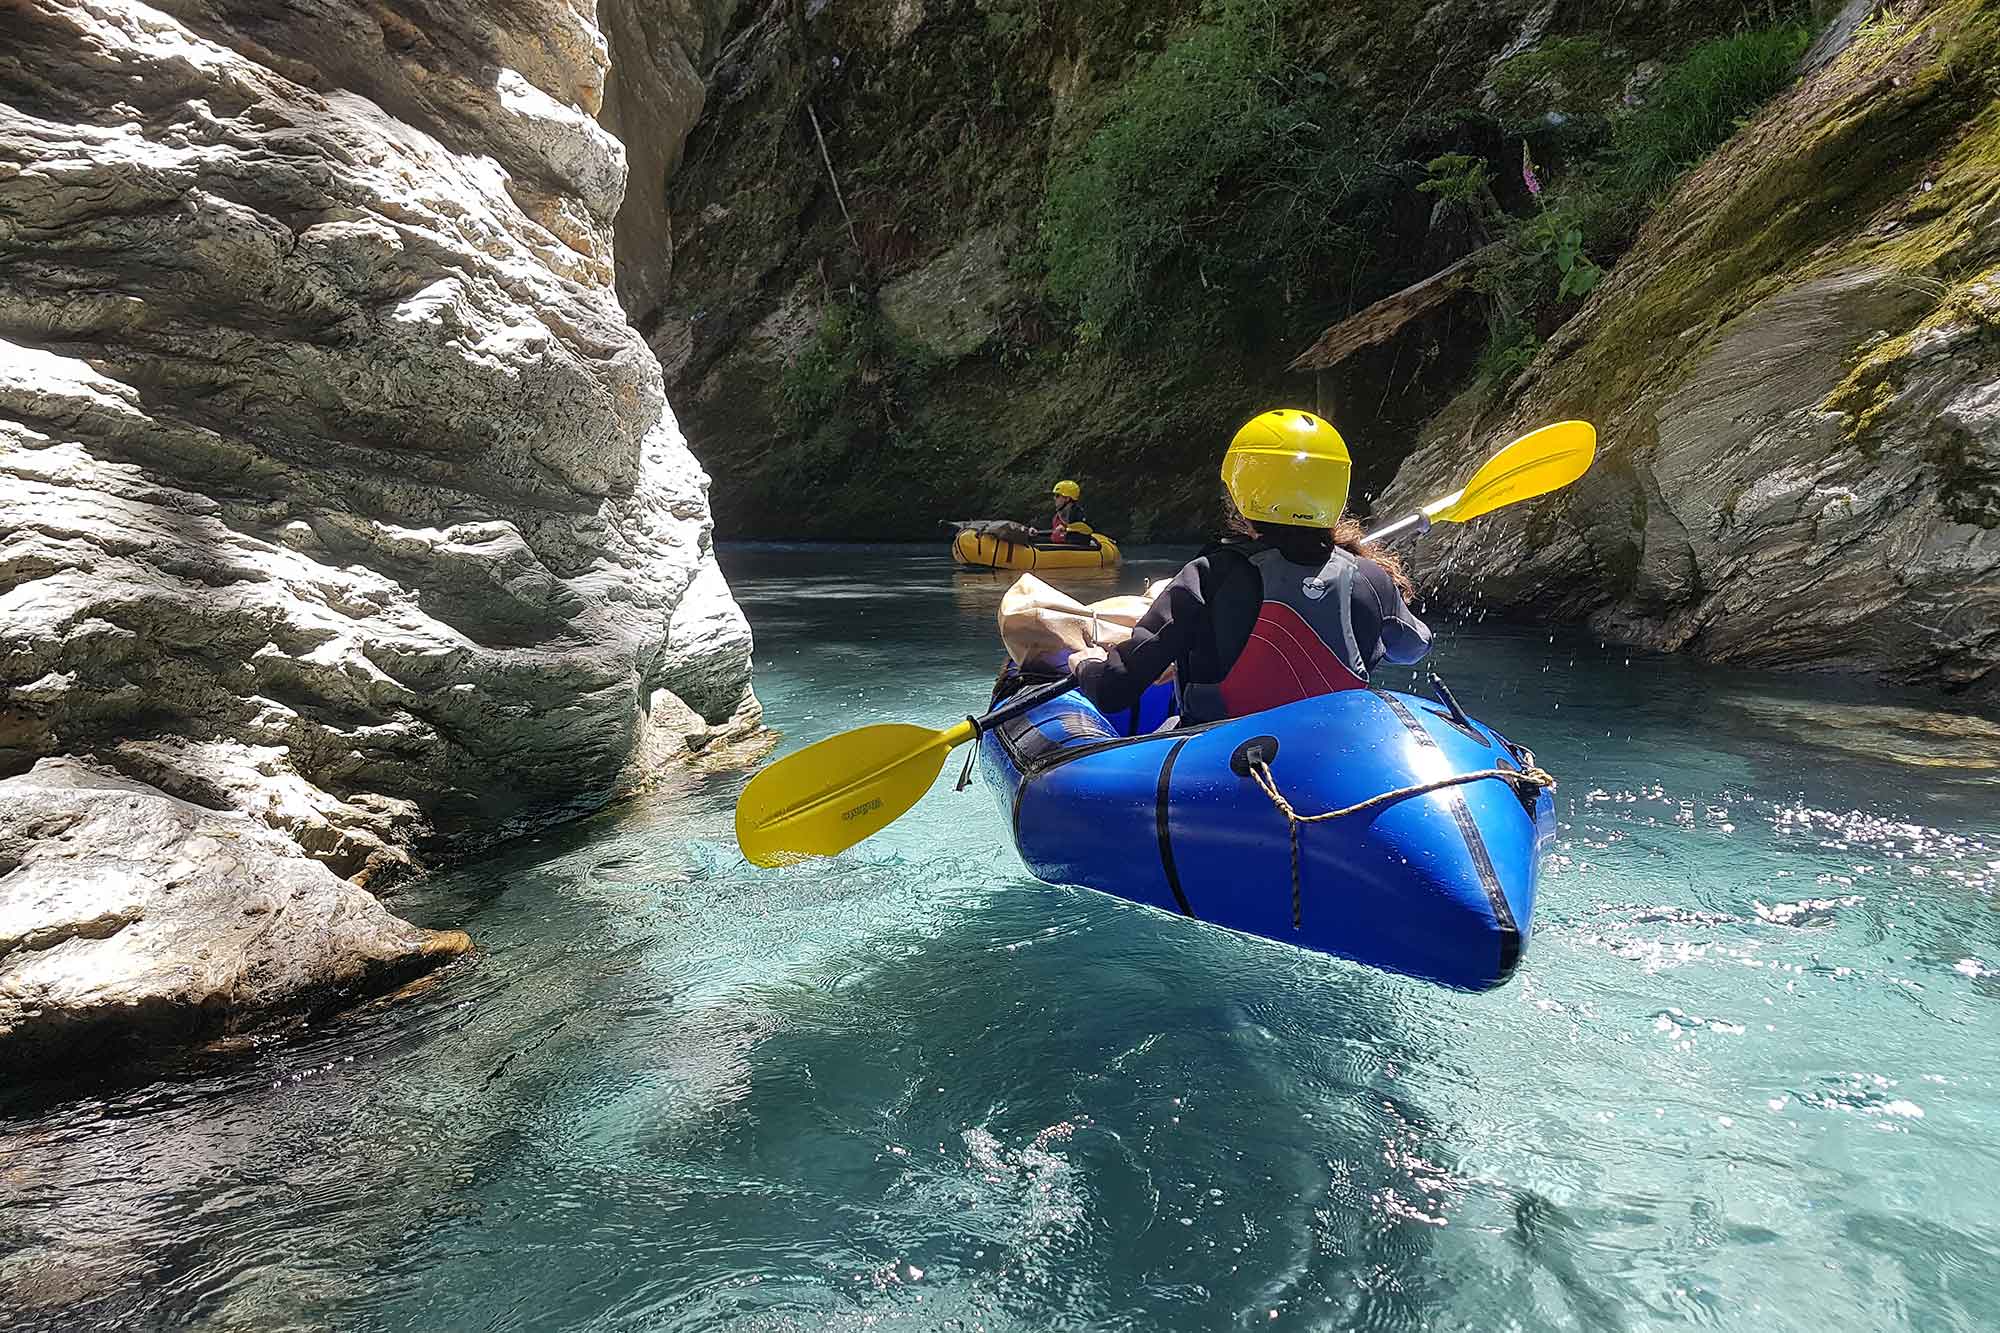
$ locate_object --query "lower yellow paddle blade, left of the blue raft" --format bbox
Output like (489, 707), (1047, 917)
(736, 723), (974, 865)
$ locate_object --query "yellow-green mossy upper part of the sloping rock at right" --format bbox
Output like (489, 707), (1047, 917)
(1512, 0), (2000, 462)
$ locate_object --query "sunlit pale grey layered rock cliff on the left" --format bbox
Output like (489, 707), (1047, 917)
(0, 0), (754, 1056)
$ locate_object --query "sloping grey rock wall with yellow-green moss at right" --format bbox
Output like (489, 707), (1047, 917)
(1394, 0), (2000, 699)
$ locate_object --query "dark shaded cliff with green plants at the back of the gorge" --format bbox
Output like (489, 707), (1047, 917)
(640, 0), (1768, 538)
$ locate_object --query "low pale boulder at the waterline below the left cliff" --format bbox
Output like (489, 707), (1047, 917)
(0, 759), (468, 1075)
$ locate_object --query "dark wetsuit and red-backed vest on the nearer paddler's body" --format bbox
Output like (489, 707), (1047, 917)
(1076, 528), (1430, 725)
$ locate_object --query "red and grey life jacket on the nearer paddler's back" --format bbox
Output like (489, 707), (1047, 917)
(1182, 546), (1368, 721)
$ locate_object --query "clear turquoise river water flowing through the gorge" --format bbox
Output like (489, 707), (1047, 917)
(0, 548), (2000, 1333)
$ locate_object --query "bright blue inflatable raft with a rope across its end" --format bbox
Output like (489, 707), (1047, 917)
(980, 687), (1556, 991)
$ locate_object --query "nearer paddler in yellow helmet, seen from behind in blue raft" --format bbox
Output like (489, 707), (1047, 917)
(1068, 408), (1430, 725)
